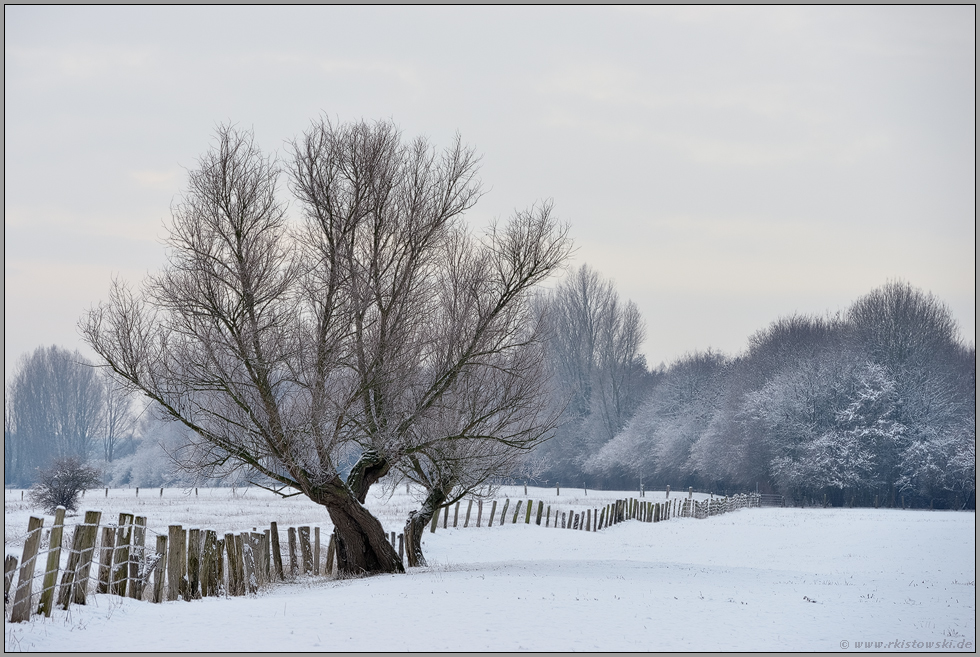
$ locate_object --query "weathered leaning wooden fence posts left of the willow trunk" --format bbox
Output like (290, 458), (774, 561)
(4, 507), (354, 622)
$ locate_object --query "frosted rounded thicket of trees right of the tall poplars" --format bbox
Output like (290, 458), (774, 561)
(585, 281), (976, 508)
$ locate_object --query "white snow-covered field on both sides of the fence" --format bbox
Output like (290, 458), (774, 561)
(4, 487), (976, 652)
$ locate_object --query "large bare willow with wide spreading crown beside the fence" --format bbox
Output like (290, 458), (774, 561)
(81, 121), (570, 574)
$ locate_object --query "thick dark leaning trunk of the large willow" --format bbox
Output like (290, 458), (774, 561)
(307, 477), (405, 577)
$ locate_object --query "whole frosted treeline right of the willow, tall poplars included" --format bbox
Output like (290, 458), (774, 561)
(537, 268), (976, 508)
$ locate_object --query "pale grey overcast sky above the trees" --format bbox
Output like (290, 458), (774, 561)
(4, 6), (976, 376)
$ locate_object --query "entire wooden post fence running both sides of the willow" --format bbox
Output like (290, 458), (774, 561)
(4, 491), (761, 622)
